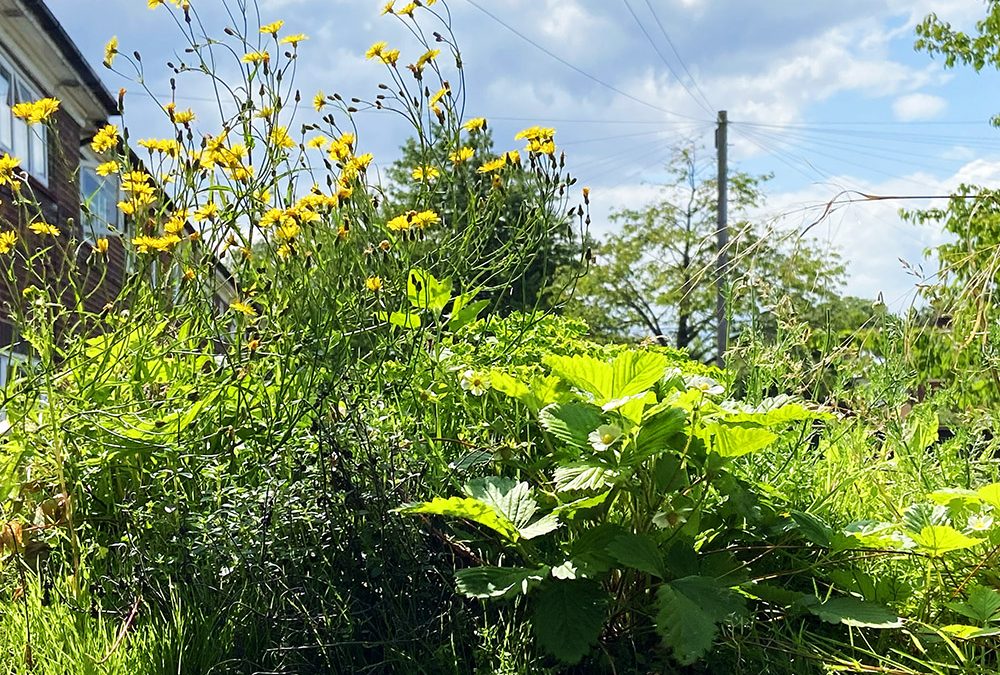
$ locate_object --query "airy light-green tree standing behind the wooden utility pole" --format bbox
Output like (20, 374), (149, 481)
(567, 149), (844, 359)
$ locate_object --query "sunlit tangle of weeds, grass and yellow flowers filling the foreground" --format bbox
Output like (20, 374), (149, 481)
(0, 0), (1000, 675)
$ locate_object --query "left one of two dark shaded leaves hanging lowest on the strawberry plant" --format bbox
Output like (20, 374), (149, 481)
(531, 579), (607, 664)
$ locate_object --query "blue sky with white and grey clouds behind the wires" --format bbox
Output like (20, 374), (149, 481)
(47, 0), (1000, 309)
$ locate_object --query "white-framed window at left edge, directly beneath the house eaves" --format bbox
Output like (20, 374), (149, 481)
(0, 49), (49, 183)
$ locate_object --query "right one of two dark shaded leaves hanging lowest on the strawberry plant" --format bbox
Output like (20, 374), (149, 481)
(656, 576), (745, 665)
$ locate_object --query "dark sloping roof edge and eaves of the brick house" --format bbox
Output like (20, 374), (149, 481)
(0, 0), (118, 118)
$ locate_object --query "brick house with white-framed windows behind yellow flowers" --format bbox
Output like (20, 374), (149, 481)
(0, 0), (233, 385)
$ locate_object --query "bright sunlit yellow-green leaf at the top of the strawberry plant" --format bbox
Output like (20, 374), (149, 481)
(545, 350), (669, 406)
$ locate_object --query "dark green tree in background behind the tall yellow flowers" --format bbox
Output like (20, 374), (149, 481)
(385, 125), (585, 314)
